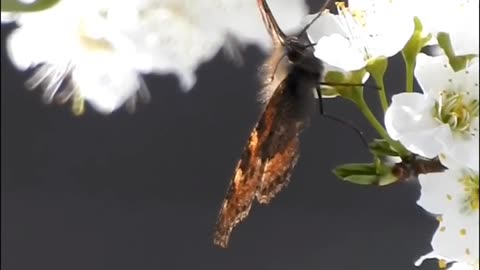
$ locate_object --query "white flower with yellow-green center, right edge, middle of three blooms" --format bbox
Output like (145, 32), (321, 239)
(385, 54), (479, 168)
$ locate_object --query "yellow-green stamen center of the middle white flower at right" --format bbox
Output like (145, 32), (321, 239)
(434, 91), (479, 133)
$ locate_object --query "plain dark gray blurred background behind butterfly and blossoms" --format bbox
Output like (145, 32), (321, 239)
(1, 3), (437, 270)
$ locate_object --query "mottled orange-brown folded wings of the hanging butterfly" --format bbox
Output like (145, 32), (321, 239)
(214, 71), (314, 247)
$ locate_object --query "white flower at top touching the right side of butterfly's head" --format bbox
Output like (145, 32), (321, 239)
(306, 0), (414, 71)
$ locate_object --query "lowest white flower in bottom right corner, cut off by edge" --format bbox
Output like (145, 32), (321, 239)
(416, 168), (479, 267)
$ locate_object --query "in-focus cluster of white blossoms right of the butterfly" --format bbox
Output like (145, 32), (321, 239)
(309, 0), (479, 269)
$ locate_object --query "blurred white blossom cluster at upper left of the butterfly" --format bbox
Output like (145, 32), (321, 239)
(2, 0), (307, 114)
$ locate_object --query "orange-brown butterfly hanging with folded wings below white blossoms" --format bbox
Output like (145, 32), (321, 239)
(213, 0), (342, 248)
